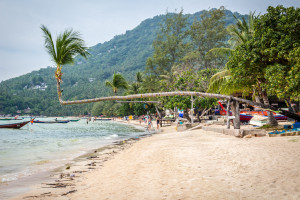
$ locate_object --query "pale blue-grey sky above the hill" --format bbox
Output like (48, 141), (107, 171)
(0, 0), (300, 82)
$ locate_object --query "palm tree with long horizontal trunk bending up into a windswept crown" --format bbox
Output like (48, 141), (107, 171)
(41, 25), (300, 121)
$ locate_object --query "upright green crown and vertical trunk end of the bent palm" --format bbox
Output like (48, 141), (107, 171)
(41, 25), (89, 102)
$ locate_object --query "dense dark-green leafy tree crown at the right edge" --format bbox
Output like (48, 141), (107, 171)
(228, 6), (300, 101)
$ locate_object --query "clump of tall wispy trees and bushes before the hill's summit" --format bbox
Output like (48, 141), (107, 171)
(147, 7), (227, 119)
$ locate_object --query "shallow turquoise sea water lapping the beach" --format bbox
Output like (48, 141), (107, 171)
(0, 119), (145, 182)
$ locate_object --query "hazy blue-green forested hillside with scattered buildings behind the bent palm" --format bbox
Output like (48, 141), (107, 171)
(0, 10), (246, 116)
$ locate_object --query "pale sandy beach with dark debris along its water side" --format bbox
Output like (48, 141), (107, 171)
(8, 120), (300, 200)
